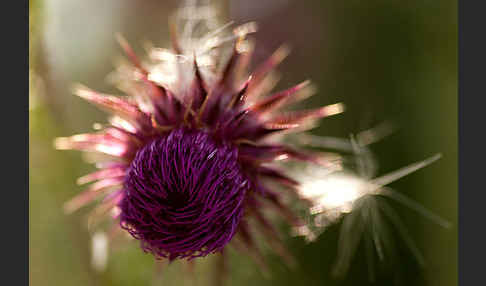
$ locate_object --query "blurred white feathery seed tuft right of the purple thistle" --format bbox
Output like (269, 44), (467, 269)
(286, 123), (450, 281)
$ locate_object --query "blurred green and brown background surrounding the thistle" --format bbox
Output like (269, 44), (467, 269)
(29, 0), (458, 286)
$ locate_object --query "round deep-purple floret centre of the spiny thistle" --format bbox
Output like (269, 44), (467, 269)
(120, 128), (249, 260)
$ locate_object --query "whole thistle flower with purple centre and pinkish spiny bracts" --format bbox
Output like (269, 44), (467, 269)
(55, 1), (343, 266)
